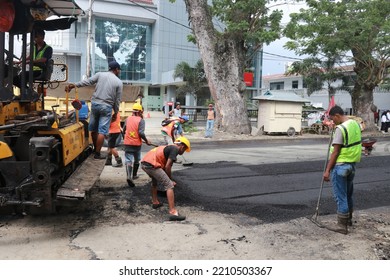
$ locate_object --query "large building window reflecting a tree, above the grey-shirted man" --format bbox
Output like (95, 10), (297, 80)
(94, 18), (151, 82)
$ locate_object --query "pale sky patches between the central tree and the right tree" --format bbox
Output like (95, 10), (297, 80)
(263, 1), (305, 76)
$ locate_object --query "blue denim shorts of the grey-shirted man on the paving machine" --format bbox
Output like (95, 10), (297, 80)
(88, 103), (112, 135)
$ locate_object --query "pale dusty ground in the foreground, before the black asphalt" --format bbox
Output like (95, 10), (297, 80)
(0, 171), (390, 260)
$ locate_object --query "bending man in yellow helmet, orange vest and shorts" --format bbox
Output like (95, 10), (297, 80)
(141, 136), (191, 221)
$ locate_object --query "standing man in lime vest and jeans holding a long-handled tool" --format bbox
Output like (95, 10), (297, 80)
(323, 105), (362, 234)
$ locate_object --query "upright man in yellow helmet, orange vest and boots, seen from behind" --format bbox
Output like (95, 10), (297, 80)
(123, 103), (151, 187)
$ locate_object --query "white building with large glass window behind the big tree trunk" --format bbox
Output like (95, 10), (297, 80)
(42, 0), (261, 110)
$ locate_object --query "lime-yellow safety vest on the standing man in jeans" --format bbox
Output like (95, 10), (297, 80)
(330, 120), (362, 163)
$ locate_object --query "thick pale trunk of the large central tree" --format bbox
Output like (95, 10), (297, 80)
(185, 0), (251, 134)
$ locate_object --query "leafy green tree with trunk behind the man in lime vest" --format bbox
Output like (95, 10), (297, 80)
(284, 0), (390, 128)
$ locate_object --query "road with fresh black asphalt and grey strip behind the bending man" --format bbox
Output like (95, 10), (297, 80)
(174, 139), (390, 222)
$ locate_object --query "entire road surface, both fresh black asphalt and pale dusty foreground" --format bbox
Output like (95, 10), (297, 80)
(0, 137), (390, 260)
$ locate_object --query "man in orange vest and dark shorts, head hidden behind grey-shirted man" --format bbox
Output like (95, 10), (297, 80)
(106, 112), (123, 167)
